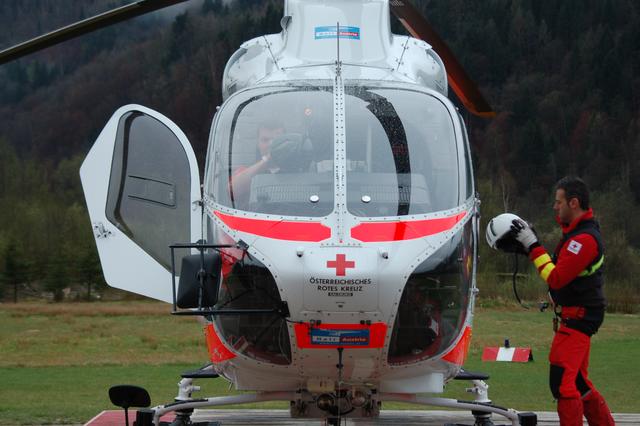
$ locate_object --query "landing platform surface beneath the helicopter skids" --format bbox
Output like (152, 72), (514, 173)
(85, 409), (640, 426)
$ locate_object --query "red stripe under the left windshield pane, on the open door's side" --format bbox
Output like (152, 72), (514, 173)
(213, 210), (331, 243)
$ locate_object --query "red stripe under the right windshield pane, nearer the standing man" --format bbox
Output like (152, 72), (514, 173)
(351, 212), (467, 243)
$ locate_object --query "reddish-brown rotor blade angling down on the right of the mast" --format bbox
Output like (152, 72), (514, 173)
(389, 0), (496, 118)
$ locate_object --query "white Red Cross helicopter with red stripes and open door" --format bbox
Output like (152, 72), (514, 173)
(0, 0), (537, 425)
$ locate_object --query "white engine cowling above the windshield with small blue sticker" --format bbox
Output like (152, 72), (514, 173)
(222, 0), (448, 99)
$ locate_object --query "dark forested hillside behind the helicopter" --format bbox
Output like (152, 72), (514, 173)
(0, 0), (640, 309)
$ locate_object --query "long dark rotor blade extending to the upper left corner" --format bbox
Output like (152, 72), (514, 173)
(0, 0), (188, 65)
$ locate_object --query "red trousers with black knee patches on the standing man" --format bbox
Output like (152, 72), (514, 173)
(549, 325), (615, 426)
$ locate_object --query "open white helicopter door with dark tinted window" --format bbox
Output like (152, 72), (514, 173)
(80, 105), (202, 302)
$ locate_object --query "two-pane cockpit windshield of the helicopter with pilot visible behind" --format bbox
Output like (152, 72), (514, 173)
(207, 80), (465, 217)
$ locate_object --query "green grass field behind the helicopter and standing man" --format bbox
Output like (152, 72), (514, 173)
(0, 302), (640, 425)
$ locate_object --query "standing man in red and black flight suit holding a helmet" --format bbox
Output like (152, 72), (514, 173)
(512, 177), (615, 426)
